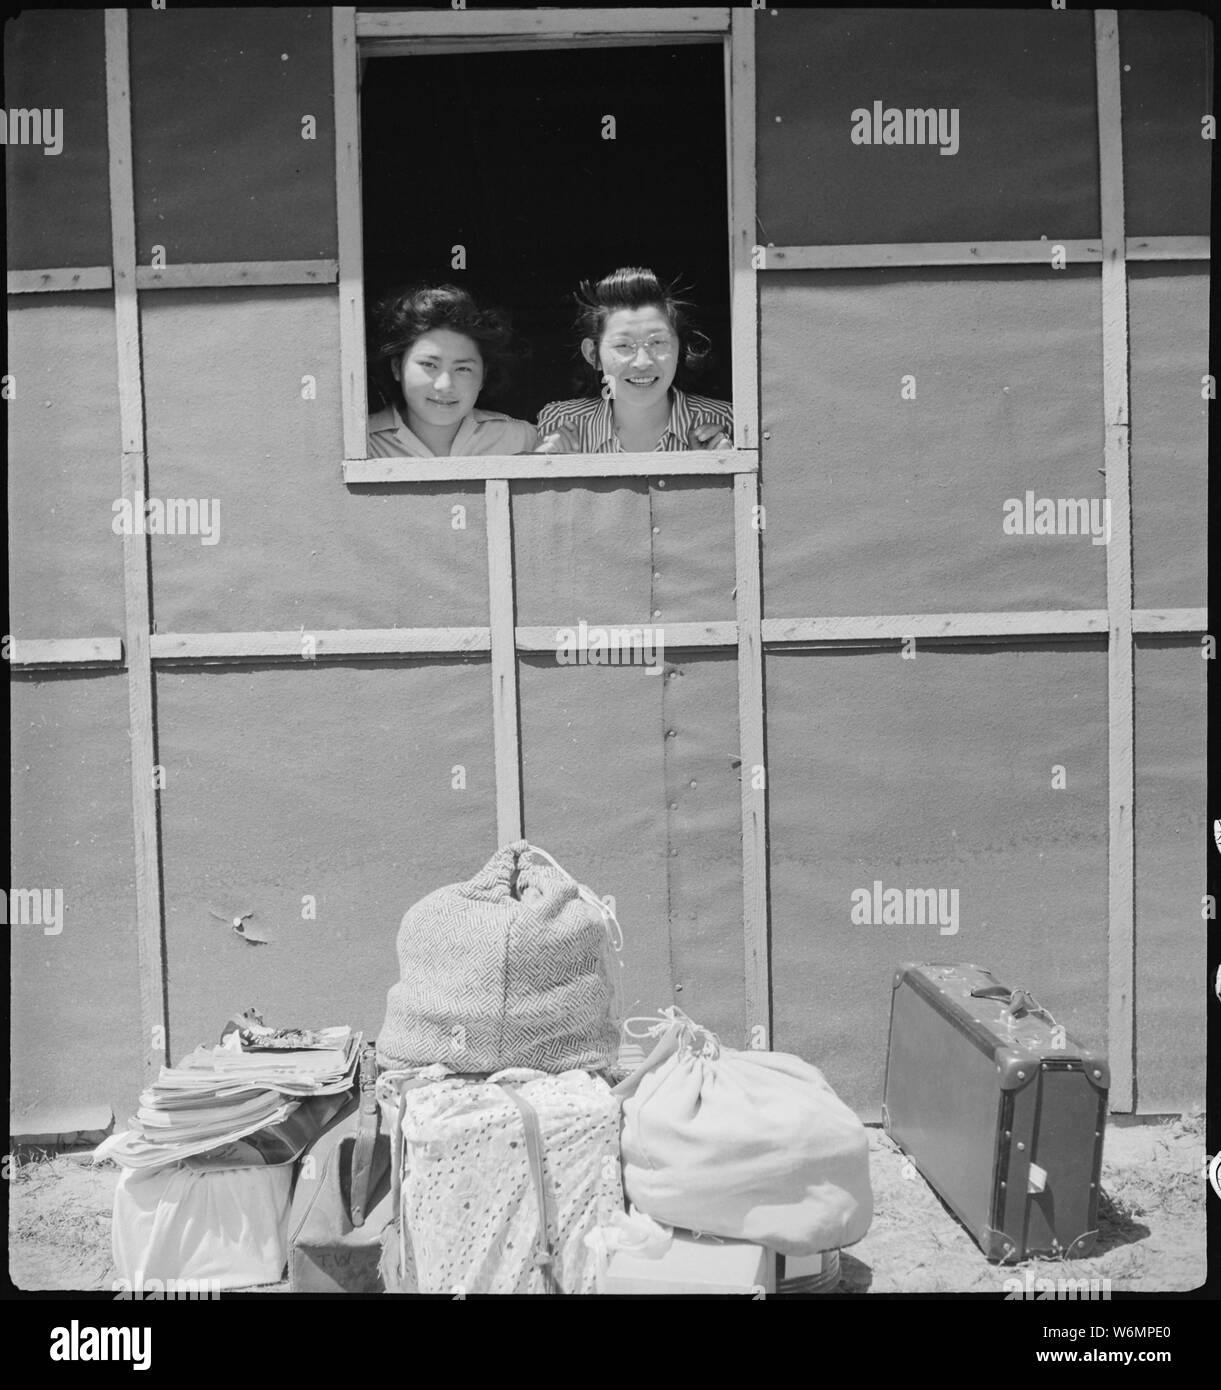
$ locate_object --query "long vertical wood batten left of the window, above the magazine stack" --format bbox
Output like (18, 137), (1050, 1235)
(106, 10), (170, 1076)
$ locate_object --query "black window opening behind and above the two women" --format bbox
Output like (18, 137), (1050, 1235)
(362, 43), (731, 420)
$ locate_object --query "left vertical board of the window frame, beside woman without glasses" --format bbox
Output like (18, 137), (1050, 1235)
(332, 6), (369, 459)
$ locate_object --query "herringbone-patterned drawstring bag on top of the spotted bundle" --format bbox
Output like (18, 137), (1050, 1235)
(377, 840), (622, 1073)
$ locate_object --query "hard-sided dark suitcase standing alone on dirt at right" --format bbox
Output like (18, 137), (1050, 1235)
(882, 965), (1110, 1261)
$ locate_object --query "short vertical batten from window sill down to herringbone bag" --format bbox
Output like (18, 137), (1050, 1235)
(484, 478), (521, 845)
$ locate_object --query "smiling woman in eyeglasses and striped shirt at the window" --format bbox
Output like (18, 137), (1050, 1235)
(537, 265), (733, 453)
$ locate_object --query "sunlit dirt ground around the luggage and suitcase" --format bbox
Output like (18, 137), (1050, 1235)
(8, 1116), (1206, 1294)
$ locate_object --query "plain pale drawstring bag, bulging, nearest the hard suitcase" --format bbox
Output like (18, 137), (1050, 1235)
(615, 1009), (873, 1255)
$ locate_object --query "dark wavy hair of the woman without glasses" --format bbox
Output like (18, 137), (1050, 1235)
(369, 285), (523, 410)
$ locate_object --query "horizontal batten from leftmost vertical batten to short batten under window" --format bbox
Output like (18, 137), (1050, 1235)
(150, 627), (491, 662)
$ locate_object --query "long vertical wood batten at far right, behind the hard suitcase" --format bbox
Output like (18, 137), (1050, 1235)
(1094, 10), (1136, 1111)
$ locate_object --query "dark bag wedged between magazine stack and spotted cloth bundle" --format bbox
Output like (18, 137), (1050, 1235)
(288, 1043), (394, 1294)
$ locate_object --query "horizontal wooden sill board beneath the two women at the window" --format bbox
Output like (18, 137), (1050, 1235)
(343, 449), (759, 484)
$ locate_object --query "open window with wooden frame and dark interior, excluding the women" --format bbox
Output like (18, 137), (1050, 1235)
(335, 8), (757, 482)
